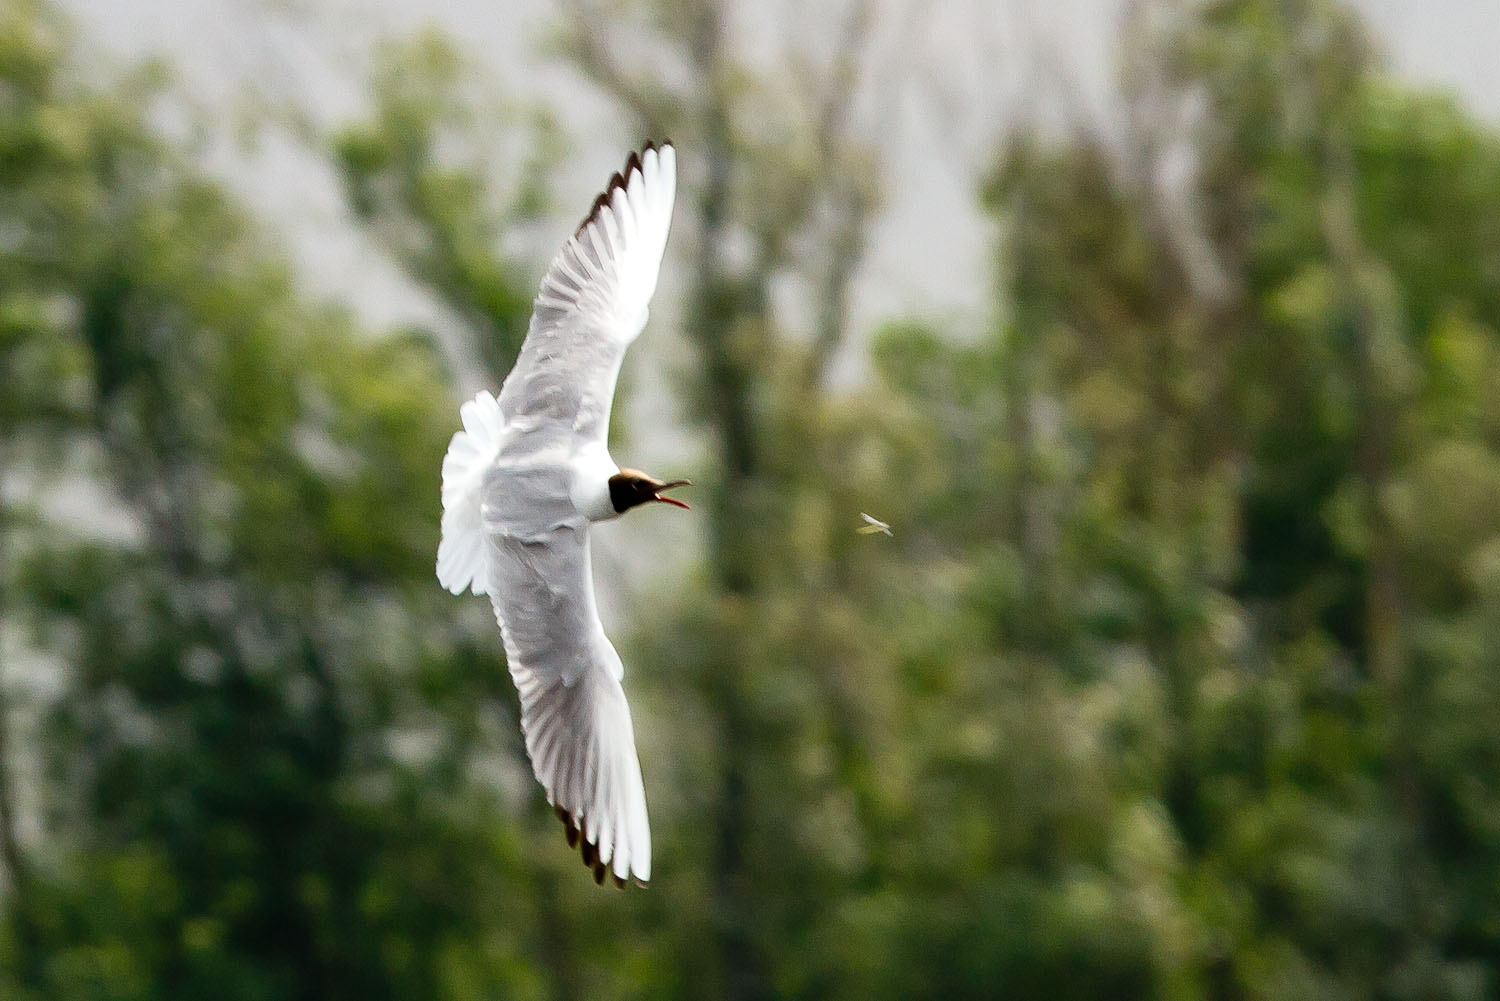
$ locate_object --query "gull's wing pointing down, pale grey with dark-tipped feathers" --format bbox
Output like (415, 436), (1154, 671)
(488, 518), (651, 885)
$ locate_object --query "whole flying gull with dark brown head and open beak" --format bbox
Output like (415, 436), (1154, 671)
(437, 143), (690, 887)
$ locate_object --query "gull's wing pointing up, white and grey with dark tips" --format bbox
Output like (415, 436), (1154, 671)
(500, 143), (677, 441)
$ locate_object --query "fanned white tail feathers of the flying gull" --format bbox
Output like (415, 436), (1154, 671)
(438, 392), (506, 594)
